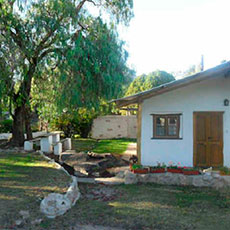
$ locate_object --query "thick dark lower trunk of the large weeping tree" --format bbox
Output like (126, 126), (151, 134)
(11, 106), (25, 147)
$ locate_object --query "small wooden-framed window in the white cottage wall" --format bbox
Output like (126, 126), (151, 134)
(152, 114), (181, 139)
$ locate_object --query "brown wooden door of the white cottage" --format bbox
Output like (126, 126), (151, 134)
(193, 112), (223, 167)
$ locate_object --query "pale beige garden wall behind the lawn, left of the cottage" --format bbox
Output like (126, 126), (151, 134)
(91, 115), (137, 139)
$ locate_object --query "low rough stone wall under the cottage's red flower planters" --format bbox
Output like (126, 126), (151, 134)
(124, 171), (230, 189)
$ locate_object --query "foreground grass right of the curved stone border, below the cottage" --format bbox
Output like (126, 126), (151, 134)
(34, 184), (230, 230)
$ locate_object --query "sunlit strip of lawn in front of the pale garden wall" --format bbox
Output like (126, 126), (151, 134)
(72, 138), (136, 154)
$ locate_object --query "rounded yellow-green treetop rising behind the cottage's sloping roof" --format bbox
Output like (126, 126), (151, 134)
(126, 70), (175, 96)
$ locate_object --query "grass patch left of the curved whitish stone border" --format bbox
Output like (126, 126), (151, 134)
(0, 152), (71, 229)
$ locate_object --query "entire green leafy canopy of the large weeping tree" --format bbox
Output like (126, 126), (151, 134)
(0, 0), (133, 143)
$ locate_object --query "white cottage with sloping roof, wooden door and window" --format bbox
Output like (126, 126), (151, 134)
(114, 62), (230, 167)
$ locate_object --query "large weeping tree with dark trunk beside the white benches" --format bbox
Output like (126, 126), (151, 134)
(0, 0), (133, 145)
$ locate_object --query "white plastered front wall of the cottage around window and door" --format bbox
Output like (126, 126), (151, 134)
(141, 77), (230, 166)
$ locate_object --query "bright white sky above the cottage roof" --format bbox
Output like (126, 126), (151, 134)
(119, 0), (230, 76)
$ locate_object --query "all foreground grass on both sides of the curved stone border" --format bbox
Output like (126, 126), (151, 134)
(0, 153), (230, 230)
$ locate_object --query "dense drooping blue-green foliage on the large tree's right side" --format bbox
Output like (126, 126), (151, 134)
(56, 18), (133, 109)
